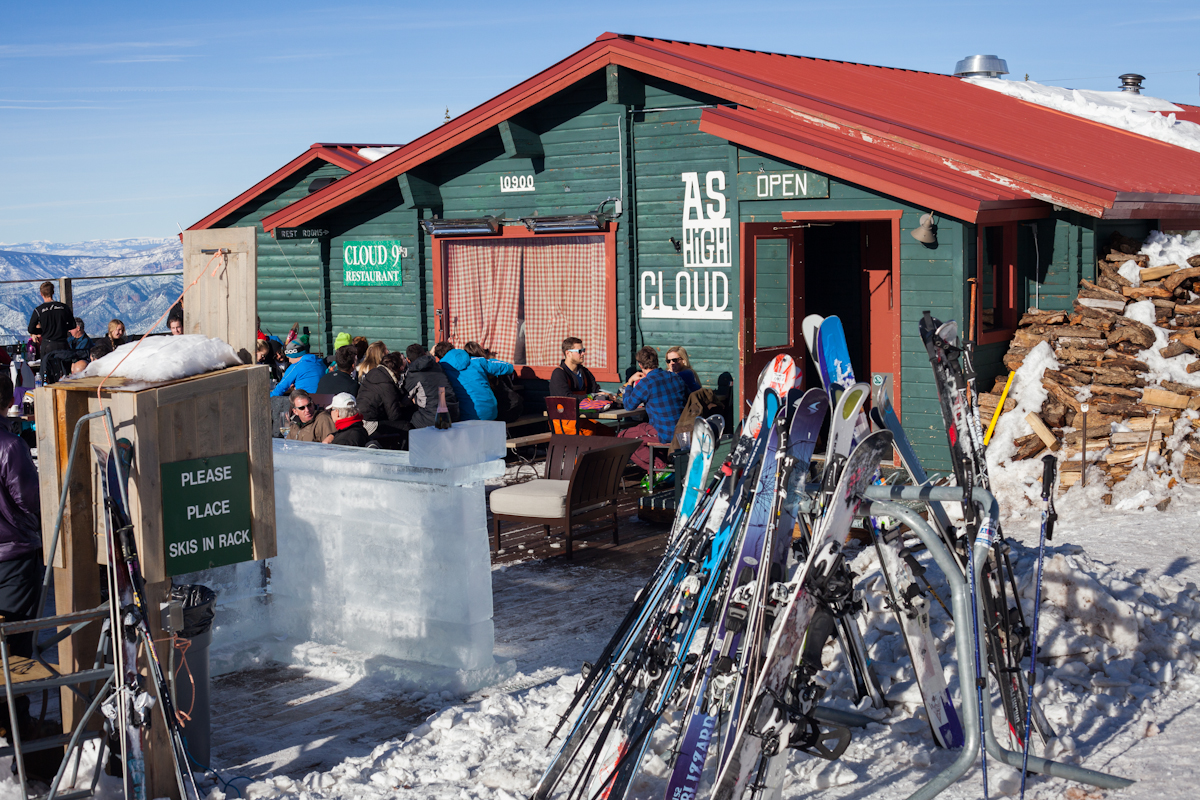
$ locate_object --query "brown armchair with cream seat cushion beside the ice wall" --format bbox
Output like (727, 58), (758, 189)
(490, 434), (641, 558)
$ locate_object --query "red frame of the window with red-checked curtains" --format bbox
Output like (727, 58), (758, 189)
(432, 222), (622, 383)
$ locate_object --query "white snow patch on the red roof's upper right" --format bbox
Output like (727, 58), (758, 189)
(964, 78), (1200, 152)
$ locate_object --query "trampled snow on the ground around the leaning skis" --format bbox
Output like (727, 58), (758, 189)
(140, 501), (1200, 800)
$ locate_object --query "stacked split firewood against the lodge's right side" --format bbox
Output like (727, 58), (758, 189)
(979, 235), (1200, 488)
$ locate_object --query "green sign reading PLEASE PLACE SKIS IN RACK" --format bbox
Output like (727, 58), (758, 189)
(161, 453), (254, 575)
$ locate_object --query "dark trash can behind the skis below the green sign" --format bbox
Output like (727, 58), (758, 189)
(170, 584), (217, 769)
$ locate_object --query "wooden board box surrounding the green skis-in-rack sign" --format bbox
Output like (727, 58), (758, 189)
(36, 366), (275, 583)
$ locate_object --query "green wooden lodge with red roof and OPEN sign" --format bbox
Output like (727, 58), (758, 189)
(193, 34), (1200, 468)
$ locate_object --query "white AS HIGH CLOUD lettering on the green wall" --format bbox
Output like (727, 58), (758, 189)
(637, 170), (733, 319)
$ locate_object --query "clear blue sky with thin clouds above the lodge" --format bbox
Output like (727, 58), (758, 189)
(0, 0), (1200, 242)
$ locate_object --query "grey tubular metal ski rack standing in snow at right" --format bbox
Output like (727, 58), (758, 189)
(858, 485), (1133, 800)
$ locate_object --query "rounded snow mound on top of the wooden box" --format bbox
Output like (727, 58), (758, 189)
(79, 333), (241, 383)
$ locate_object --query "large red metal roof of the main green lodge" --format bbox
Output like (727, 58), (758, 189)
(263, 34), (1200, 229)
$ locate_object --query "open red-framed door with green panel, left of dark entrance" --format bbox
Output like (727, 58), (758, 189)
(739, 223), (808, 416)
